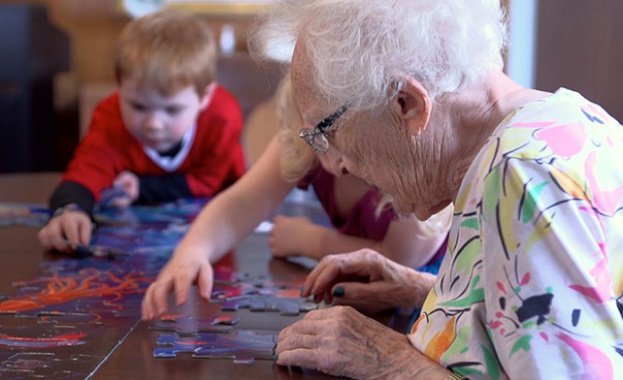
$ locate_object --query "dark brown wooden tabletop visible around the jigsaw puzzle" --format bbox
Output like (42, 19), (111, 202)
(0, 173), (405, 380)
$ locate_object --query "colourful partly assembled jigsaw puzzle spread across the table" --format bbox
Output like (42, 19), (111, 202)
(0, 199), (317, 379)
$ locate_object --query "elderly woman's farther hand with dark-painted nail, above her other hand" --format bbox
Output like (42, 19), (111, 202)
(303, 249), (435, 312)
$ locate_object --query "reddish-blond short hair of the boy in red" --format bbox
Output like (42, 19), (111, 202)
(115, 9), (218, 96)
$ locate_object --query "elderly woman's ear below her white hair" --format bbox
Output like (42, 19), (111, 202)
(391, 77), (432, 136)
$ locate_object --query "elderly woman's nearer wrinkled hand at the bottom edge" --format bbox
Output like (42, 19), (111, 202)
(275, 306), (422, 379)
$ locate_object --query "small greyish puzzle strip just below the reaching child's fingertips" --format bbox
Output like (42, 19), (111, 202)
(149, 314), (240, 335)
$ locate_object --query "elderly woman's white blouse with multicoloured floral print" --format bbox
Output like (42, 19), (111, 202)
(409, 89), (623, 380)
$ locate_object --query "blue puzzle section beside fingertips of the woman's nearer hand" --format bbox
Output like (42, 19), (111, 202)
(153, 330), (278, 364)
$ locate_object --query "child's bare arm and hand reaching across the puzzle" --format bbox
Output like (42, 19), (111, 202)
(142, 138), (292, 320)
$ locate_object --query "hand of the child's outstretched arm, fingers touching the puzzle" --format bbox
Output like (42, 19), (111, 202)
(142, 247), (214, 320)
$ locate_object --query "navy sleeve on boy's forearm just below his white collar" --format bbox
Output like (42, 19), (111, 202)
(136, 173), (192, 204)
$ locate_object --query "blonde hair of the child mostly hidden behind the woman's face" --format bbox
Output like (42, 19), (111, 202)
(275, 74), (318, 182)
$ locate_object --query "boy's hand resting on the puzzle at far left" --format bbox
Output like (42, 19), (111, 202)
(37, 210), (93, 252)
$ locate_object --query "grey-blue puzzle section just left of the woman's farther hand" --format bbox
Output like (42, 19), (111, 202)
(221, 294), (318, 315)
